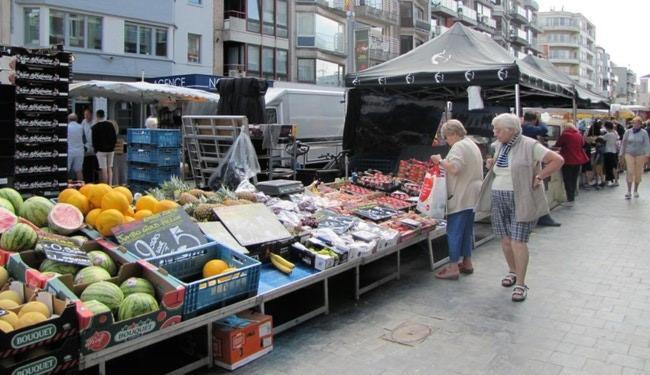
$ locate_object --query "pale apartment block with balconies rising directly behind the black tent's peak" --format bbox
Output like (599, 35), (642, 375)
(431, 0), (541, 57)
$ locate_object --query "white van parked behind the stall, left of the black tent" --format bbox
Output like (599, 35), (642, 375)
(265, 81), (345, 165)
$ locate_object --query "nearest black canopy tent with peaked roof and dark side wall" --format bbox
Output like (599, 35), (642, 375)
(343, 23), (574, 160)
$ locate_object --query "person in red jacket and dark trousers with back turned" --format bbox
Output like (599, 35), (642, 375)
(555, 122), (590, 207)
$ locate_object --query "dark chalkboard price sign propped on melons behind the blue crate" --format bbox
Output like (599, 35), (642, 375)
(113, 207), (207, 259)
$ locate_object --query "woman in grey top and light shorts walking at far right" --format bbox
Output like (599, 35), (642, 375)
(620, 117), (650, 199)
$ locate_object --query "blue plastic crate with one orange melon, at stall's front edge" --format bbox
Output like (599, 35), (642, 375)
(147, 242), (261, 317)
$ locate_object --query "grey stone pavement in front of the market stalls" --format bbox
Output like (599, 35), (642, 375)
(200, 181), (650, 375)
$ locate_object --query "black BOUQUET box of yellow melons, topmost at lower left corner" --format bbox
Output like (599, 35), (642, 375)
(0, 281), (79, 358)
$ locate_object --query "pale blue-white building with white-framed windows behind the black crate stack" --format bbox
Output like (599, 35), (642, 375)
(10, 0), (214, 80)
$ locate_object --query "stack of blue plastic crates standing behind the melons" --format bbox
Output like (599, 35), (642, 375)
(127, 129), (181, 192)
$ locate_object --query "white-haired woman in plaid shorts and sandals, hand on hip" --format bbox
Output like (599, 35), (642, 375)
(478, 113), (564, 302)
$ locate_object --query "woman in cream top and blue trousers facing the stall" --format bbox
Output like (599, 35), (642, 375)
(431, 120), (483, 280)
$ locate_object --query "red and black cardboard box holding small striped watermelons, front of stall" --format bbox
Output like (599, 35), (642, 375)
(48, 261), (185, 354)
